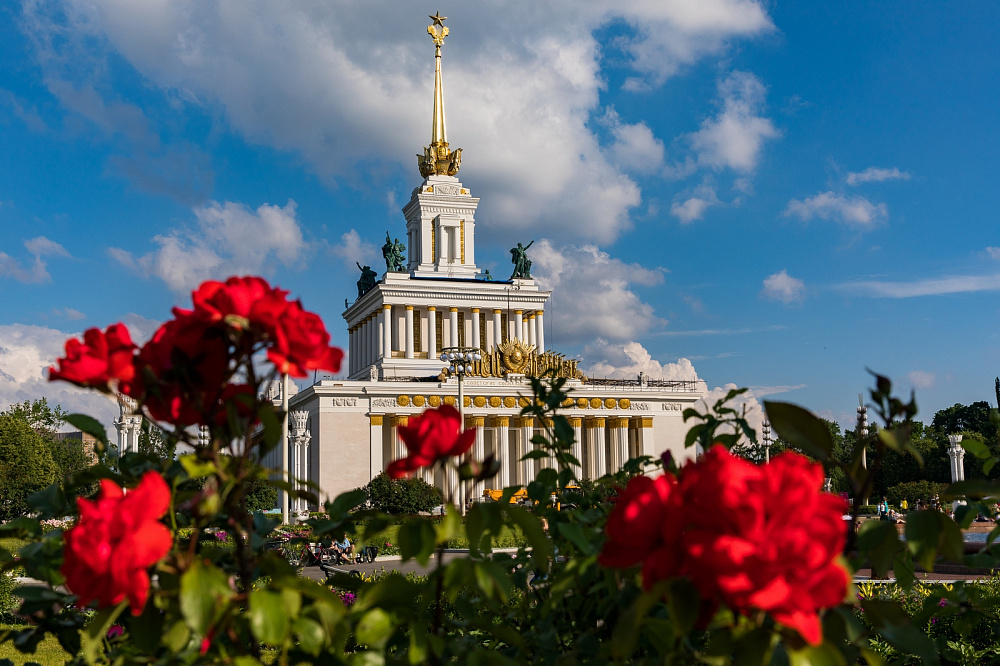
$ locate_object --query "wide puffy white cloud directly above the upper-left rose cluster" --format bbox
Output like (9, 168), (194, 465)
(108, 201), (305, 293)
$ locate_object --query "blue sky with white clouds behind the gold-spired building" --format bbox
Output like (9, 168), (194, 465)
(0, 0), (1000, 430)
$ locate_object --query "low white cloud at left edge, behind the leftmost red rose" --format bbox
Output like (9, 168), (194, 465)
(0, 324), (118, 428)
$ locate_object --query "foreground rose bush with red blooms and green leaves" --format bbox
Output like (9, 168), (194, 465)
(0, 277), (1000, 666)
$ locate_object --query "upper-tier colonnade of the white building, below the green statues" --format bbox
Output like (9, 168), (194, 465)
(347, 303), (545, 374)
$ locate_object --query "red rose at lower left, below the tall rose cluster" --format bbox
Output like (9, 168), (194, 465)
(62, 472), (172, 615)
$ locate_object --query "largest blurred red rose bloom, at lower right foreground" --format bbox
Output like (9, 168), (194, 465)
(601, 446), (848, 645)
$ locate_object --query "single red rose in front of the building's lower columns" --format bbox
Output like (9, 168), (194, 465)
(386, 405), (476, 479)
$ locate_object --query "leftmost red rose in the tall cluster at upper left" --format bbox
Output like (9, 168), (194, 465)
(49, 323), (136, 392)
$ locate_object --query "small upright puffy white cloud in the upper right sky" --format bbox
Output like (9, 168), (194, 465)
(690, 72), (781, 172)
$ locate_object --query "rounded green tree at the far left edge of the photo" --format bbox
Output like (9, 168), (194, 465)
(0, 414), (59, 522)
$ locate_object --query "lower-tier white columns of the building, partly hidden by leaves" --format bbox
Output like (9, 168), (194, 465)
(370, 414), (655, 497)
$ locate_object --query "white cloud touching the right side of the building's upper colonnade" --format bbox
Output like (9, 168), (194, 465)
(531, 240), (666, 342)
